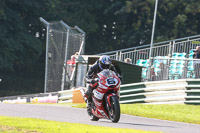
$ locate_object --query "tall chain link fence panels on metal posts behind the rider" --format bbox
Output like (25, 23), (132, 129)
(40, 18), (85, 93)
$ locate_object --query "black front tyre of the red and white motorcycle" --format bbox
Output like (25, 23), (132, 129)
(108, 96), (120, 123)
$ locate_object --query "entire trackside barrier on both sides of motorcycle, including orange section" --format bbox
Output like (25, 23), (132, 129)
(0, 79), (200, 104)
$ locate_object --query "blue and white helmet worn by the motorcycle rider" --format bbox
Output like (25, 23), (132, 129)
(99, 55), (112, 70)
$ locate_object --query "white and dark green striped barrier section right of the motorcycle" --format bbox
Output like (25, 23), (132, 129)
(120, 79), (200, 104)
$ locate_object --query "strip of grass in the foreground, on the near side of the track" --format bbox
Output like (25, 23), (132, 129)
(0, 116), (159, 133)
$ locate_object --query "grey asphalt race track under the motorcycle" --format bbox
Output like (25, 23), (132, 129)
(0, 103), (200, 133)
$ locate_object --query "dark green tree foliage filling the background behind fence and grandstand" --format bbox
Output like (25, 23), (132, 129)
(0, 0), (200, 96)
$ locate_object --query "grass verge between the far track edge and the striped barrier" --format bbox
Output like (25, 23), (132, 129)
(73, 104), (200, 124)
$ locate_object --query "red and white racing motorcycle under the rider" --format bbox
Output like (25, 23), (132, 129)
(81, 69), (121, 123)
